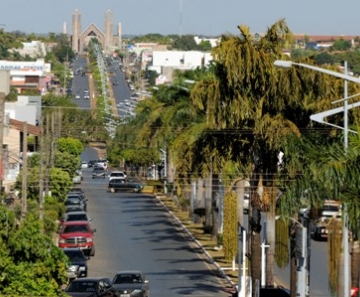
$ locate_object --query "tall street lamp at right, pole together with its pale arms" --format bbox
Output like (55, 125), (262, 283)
(274, 60), (354, 297)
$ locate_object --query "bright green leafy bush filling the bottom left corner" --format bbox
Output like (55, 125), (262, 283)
(0, 207), (68, 297)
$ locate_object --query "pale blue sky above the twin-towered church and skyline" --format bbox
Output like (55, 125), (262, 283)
(0, 0), (360, 36)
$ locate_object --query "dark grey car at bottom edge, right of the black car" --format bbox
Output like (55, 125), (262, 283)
(112, 270), (150, 297)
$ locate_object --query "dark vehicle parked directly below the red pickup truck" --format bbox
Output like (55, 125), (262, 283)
(63, 248), (88, 280)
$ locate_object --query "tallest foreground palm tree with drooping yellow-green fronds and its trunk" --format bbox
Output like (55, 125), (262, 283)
(192, 20), (352, 294)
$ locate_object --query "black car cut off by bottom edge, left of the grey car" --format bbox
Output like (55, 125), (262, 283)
(65, 277), (119, 297)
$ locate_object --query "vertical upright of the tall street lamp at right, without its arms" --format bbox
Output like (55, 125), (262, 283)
(342, 61), (351, 297)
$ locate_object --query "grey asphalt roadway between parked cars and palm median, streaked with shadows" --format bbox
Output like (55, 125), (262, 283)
(82, 149), (229, 297)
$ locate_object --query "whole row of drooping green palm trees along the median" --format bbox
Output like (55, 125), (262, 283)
(108, 20), (360, 292)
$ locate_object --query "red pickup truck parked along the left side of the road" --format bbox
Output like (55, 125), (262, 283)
(59, 221), (96, 256)
